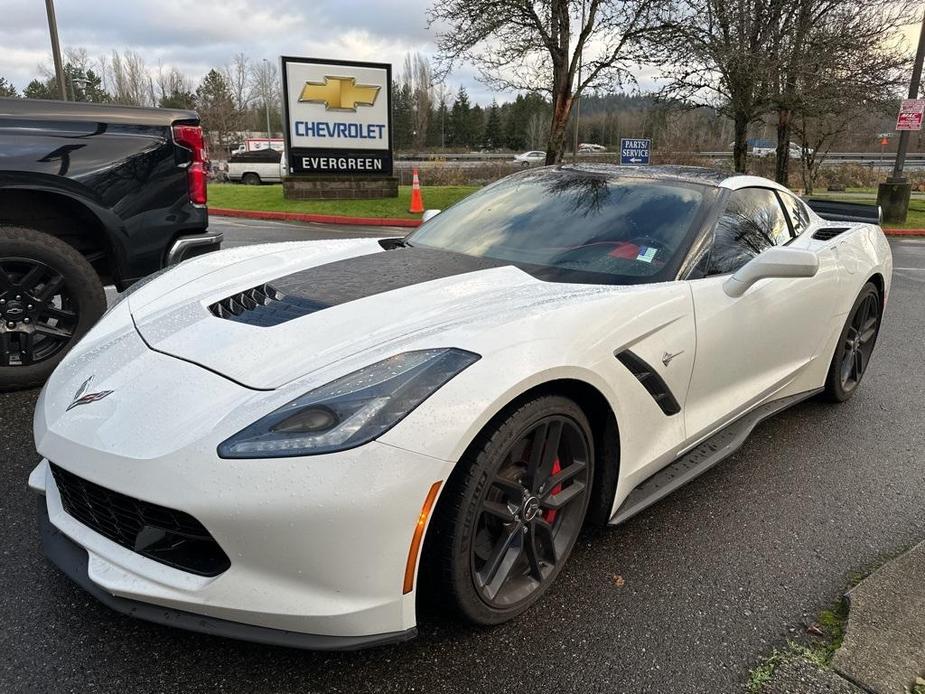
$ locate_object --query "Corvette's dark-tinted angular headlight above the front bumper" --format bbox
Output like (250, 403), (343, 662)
(218, 349), (479, 458)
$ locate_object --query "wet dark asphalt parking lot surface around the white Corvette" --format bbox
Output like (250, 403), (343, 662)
(0, 220), (925, 694)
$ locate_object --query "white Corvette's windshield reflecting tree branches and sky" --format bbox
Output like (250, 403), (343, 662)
(407, 169), (714, 284)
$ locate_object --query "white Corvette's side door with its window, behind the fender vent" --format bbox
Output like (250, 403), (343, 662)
(685, 187), (837, 439)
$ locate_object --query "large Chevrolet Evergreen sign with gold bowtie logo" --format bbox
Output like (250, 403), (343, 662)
(281, 56), (392, 176)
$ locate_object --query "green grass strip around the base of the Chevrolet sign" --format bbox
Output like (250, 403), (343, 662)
(209, 183), (479, 219)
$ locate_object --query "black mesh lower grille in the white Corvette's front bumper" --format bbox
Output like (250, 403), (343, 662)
(51, 463), (231, 576)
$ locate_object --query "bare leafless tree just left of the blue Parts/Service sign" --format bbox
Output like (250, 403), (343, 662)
(429, 0), (664, 164)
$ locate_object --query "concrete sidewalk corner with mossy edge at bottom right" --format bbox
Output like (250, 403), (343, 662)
(762, 542), (925, 694)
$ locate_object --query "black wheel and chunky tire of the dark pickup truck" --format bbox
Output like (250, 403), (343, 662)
(0, 227), (106, 390)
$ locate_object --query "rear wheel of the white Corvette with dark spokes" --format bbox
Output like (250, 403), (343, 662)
(825, 282), (882, 402)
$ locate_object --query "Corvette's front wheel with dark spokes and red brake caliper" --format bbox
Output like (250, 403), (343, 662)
(424, 395), (594, 625)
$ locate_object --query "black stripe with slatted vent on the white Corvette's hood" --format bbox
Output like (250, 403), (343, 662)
(209, 247), (510, 327)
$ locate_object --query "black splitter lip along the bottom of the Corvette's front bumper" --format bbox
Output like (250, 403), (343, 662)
(39, 500), (417, 651)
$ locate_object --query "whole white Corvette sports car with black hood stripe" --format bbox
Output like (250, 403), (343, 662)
(30, 166), (892, 649)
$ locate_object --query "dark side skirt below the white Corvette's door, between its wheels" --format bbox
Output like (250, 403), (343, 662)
(610, 388), (822, 525)
